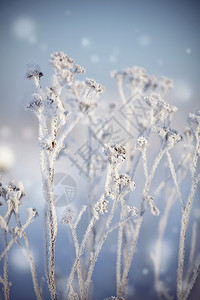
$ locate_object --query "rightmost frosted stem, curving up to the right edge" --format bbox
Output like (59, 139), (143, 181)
(177, 174), (200, 300)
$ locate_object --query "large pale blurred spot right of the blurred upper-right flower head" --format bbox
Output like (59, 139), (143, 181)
(174, 80), (192, 102)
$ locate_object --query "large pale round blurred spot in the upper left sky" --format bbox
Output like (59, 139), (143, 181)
(13, 17), (36, 39)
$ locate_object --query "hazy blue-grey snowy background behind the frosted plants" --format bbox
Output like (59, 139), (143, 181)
(0, 0), (200, 300)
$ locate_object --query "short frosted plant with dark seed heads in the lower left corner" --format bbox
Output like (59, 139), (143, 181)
(0, 182), (42, 300)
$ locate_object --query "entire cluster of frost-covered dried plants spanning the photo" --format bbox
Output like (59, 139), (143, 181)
(0, 52), (200, 300)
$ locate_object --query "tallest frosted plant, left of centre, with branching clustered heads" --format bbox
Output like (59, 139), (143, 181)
(26, 52), (103, 300)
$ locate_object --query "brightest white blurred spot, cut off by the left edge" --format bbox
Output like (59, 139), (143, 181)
(0, 145), (15, 172)
